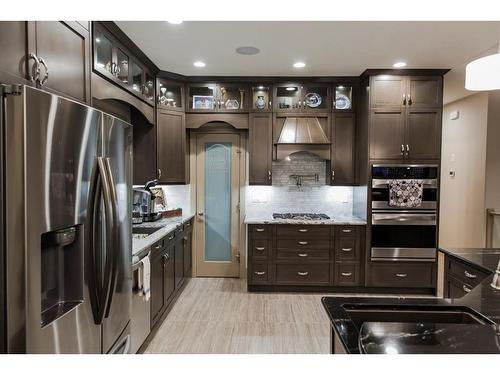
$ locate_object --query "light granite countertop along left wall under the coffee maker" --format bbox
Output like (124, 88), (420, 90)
(132, 213), (194, 263)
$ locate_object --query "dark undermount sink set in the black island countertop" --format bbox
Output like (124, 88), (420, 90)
(343, 304), (493, 331)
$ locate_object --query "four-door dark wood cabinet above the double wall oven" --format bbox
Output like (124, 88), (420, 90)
(369, 75), (443, 161)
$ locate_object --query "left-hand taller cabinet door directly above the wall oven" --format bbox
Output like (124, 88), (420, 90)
(370, 109), (404, 160)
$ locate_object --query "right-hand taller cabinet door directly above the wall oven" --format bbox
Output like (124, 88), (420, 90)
(405, 108), (441, 160)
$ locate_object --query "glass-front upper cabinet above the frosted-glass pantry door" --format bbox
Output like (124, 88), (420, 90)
(186, 83), (249, 112)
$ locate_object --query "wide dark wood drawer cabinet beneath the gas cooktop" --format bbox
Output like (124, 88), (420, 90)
(248, 224), (365, 290)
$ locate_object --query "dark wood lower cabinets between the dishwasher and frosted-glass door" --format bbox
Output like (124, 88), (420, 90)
(151, 219), (193, 328)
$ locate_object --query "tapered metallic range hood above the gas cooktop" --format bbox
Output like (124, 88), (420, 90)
(276, 117), (331, 160)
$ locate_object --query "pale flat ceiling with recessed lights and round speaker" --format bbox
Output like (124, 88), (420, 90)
(117, 21), (500, 76)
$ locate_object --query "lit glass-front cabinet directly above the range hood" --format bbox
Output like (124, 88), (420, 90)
(274, 84), (330, 112)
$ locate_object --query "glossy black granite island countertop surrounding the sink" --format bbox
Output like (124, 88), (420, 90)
(322, 249), (500, 354)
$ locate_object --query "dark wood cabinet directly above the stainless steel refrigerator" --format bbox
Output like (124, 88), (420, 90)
(0, 21), (90, 103)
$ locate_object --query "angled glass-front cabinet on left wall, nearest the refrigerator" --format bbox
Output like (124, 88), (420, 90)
(93, 23), (155, 104)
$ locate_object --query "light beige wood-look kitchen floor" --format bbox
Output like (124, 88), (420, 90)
(145, 278), (430, 354)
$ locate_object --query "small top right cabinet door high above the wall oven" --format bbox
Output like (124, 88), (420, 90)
(406, 76), (443, 108)
